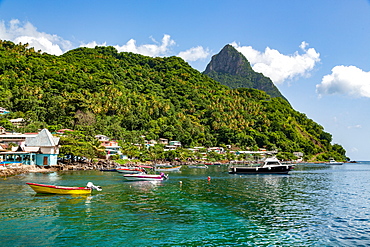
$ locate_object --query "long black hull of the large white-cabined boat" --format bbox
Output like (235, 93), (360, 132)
(229, 165), (293, 174)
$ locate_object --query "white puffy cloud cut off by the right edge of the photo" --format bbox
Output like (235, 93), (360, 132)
(316, 65), (370, 98)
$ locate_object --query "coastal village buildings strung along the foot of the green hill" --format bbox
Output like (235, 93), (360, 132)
(0, 108), (303, 176)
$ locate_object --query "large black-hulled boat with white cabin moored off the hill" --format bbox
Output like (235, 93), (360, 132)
(229, 157), (294, 174)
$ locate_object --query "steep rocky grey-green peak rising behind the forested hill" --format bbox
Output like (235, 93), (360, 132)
(203, 45), (286, 100)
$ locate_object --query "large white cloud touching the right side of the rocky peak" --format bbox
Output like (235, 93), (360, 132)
(231, 41), (320, 84)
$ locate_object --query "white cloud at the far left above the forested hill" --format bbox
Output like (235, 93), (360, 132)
(0, 19), (72, 55)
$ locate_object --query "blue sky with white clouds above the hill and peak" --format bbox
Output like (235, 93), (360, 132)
(0, 0), (370, 161)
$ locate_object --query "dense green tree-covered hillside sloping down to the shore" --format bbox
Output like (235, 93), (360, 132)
(0, 41), (345, 160)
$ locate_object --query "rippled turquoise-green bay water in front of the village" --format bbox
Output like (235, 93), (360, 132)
(0, 162), (370, 246)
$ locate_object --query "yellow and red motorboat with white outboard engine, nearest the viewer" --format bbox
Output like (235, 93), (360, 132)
(26, 182), (102, 195)
